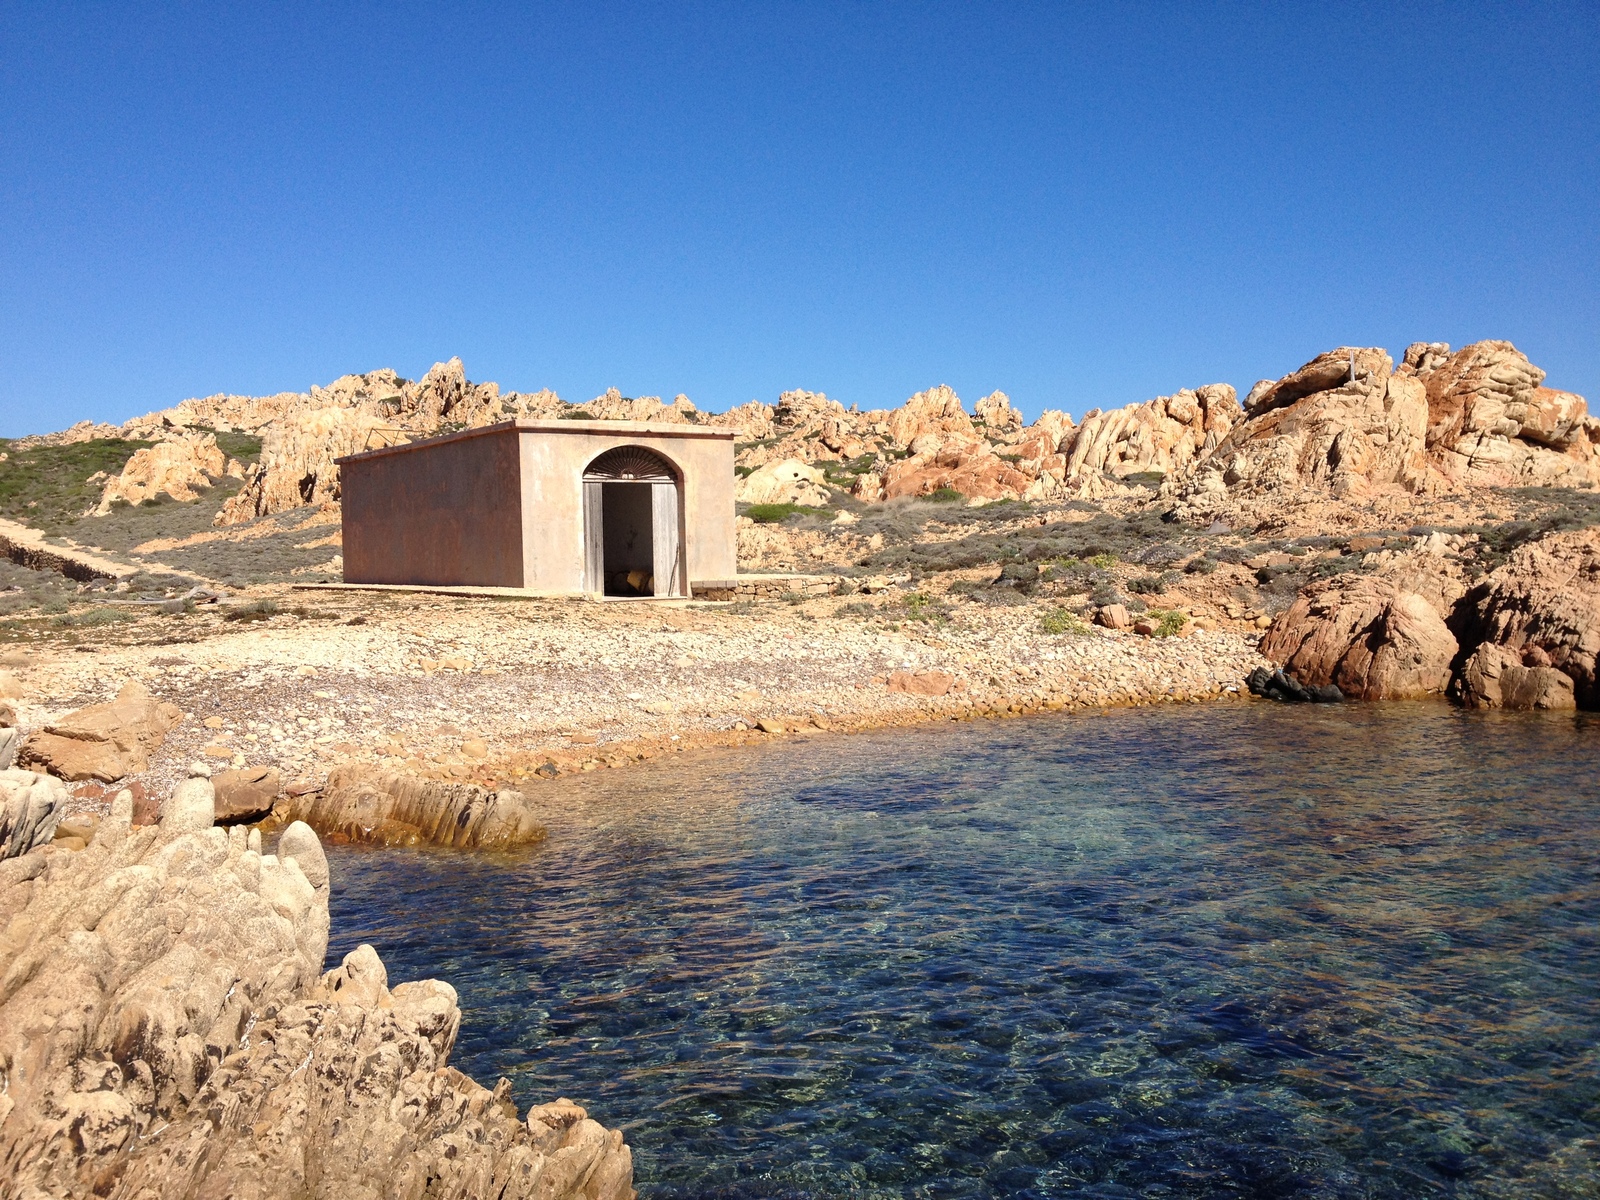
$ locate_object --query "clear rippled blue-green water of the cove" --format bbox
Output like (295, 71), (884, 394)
(330, 704), (1600, 1197)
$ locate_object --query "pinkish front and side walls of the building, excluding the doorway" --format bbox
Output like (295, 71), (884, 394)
(339, 421), (738, 595)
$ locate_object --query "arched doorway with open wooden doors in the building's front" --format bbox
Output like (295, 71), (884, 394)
(584, 446), (683, 595)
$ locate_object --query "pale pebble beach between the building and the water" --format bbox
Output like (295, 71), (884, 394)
(3, 590), (1262, 825)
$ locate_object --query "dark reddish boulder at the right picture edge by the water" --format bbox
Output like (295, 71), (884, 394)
(1451, 528), (1600, 709)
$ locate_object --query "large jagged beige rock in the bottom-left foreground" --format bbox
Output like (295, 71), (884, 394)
(0, 779), (634, 1200)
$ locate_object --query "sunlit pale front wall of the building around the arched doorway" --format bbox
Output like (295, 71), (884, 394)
(522, 430), (738, 592)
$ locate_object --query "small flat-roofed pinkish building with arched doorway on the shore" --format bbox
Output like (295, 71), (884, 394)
(338, 421), (738, 597)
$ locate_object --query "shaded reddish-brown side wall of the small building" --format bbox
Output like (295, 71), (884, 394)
(341, 429), (524, 587)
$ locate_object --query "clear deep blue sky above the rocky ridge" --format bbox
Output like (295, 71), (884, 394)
(0, 0), (1600, 435)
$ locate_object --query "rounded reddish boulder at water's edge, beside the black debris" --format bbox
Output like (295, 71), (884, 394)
(1259, 576), (1458, 699)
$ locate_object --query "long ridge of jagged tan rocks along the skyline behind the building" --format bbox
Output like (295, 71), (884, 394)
(37, 341), (1600, 540)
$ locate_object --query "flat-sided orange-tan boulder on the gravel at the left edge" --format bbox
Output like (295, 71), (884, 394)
(16, 682), (184, 782)
